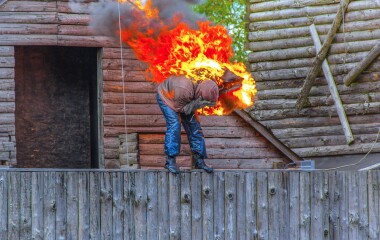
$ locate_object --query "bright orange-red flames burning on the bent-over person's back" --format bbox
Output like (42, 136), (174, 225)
(120, 0), (256, 115)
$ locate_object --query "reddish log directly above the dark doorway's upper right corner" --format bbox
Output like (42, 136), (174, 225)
(57, 35), (117, 47)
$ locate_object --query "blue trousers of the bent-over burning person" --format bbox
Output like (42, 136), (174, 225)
(157, 94), (207, 158)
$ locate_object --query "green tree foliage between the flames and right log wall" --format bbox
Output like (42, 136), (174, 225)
(194, 0), (249, 62)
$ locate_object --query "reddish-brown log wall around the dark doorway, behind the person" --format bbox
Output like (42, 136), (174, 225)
(0, 0), (288, 168)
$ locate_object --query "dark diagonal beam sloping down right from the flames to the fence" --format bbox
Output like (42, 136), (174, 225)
(235, 110), (302, 162)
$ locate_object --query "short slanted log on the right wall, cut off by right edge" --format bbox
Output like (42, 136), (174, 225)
(343, 41), (380, 86)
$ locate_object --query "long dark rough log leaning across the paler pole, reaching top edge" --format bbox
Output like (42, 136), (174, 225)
(296, 0), (350, 109)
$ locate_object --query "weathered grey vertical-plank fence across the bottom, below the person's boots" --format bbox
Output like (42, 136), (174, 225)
(0, 169), (380, 240)
